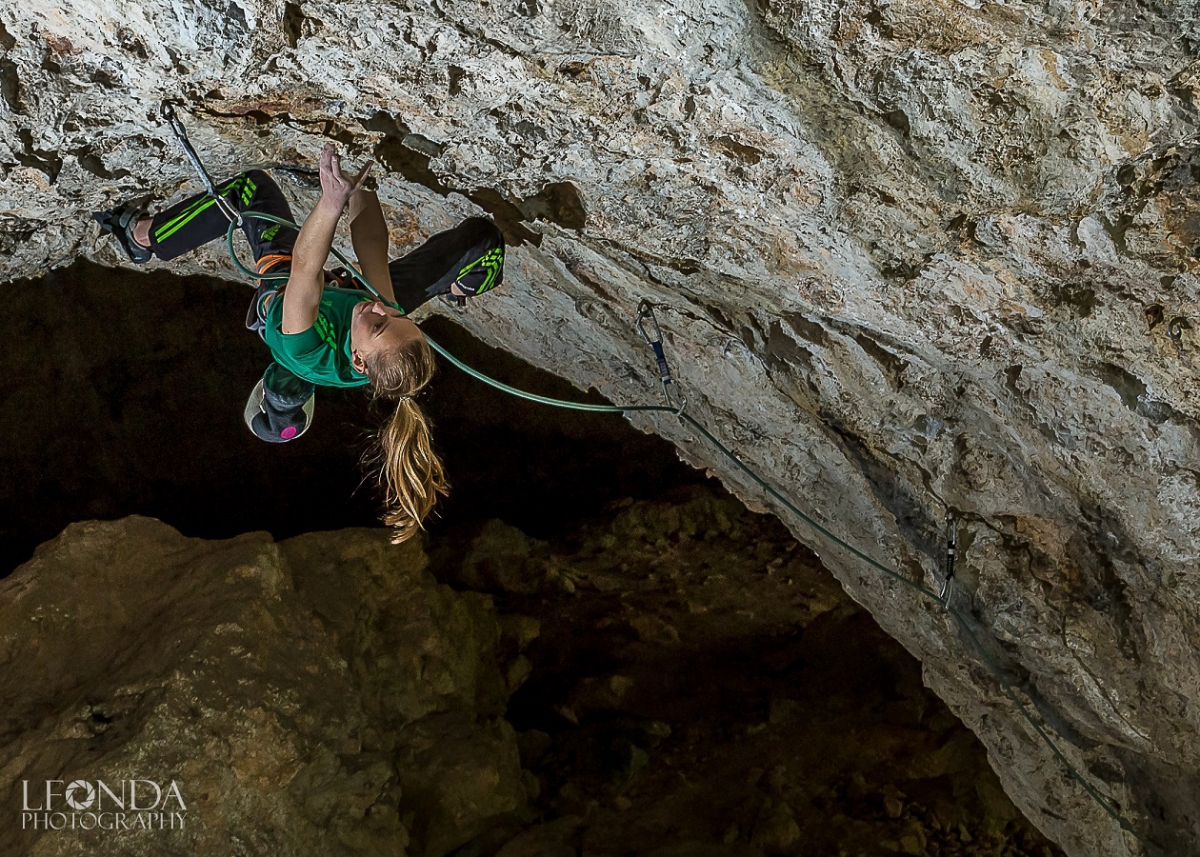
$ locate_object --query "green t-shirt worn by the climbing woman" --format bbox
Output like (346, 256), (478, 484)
(263, 287), (371, 386)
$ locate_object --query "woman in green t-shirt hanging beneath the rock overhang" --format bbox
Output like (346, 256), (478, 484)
(95, 145), (504, 543)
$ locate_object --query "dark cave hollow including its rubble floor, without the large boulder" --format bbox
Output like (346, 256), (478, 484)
(0, 256), (1057, 857)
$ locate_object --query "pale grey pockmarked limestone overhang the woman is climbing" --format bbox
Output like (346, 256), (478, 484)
(0, 0), (1200, 856)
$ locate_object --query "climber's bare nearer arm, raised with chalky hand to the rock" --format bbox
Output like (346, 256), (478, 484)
(281, 145), (371, 334)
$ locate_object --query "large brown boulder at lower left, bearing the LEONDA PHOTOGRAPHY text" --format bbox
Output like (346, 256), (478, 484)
(0, 517), (528, 857)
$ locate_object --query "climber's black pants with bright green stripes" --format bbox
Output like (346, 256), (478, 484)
(150, 169), (504, 312)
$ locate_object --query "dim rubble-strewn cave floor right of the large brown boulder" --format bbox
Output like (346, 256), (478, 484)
(434, 485), (1061, 857)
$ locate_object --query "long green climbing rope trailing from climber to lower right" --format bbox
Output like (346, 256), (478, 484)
(226, 211), (1166, 857)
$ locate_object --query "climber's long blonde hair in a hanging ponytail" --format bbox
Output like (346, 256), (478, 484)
(364, 336), (450, 545)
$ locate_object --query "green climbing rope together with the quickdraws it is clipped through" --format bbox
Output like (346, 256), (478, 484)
(162, 103), (1161, 857)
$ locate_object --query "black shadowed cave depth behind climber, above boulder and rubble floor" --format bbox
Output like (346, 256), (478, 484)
(0, 256), (704, 574)
